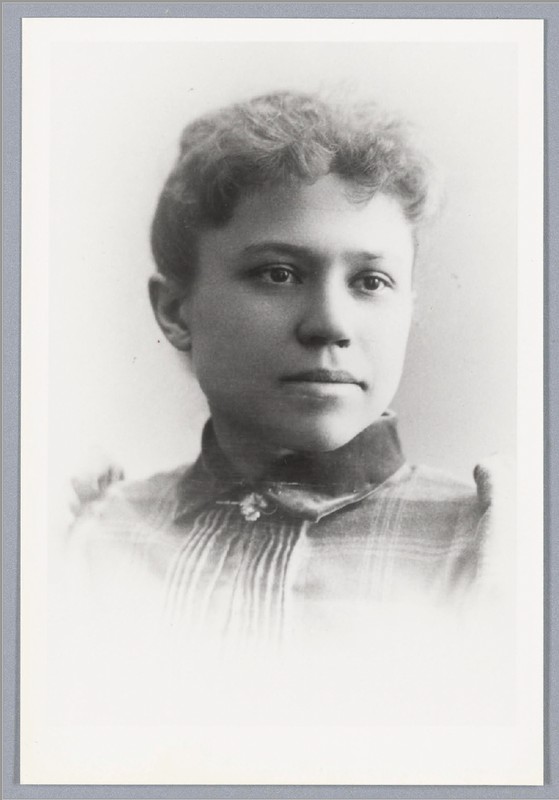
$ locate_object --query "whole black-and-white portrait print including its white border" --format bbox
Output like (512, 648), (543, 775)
(20, 14), (543, 785)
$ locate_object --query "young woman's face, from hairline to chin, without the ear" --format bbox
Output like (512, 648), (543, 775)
(180, 175), (414, 451)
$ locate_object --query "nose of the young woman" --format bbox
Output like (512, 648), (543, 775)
(296, 285), (352, 347)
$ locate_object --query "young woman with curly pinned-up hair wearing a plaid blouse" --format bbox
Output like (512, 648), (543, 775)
(68, 92), (500, 664)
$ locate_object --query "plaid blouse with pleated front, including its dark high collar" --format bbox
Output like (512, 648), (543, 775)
(70, 413), (490, 656)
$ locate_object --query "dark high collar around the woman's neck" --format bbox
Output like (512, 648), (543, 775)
(178, 412), (410, 519)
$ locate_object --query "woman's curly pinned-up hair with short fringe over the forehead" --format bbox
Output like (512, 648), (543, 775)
(151, 91), (438, 282)
